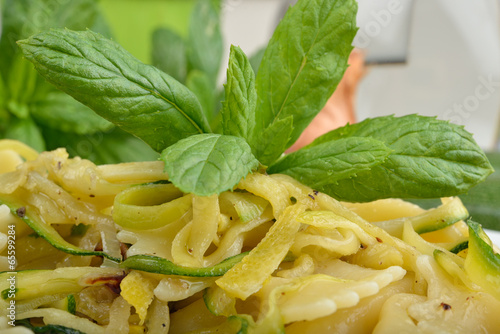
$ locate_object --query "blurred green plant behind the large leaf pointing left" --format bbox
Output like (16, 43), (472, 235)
(0, 0), (158, 163)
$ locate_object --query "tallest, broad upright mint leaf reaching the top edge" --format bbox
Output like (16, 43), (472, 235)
(255, 0), (357, 160)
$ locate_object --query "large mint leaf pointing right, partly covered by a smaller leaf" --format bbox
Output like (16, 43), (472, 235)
(308, 115), (493, 202)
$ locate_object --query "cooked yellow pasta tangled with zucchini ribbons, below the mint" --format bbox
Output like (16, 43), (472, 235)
(0, 141), (500, 333)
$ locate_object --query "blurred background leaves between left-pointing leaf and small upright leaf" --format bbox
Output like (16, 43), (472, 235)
(151, 0), (265, 133)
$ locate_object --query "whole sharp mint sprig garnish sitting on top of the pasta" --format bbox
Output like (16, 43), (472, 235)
(15, 0), (493, 201)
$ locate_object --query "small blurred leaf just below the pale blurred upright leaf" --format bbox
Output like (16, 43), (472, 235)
(186, 70), (216, 122)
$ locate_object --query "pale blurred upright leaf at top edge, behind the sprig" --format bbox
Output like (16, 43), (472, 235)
(187, 0), (223, 84)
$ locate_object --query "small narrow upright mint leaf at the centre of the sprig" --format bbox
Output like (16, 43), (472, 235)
(221, 45), (257, 141)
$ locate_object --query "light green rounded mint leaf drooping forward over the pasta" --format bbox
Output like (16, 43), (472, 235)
(161, 134), (259, 196)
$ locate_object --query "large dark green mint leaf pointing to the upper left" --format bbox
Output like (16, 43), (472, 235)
(18, 30), (210, 151)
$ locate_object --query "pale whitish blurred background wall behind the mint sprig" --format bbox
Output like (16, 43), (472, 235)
(223, 0), (500, 151)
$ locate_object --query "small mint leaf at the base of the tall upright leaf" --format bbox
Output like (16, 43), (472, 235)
(252, 116), (293, 166)
